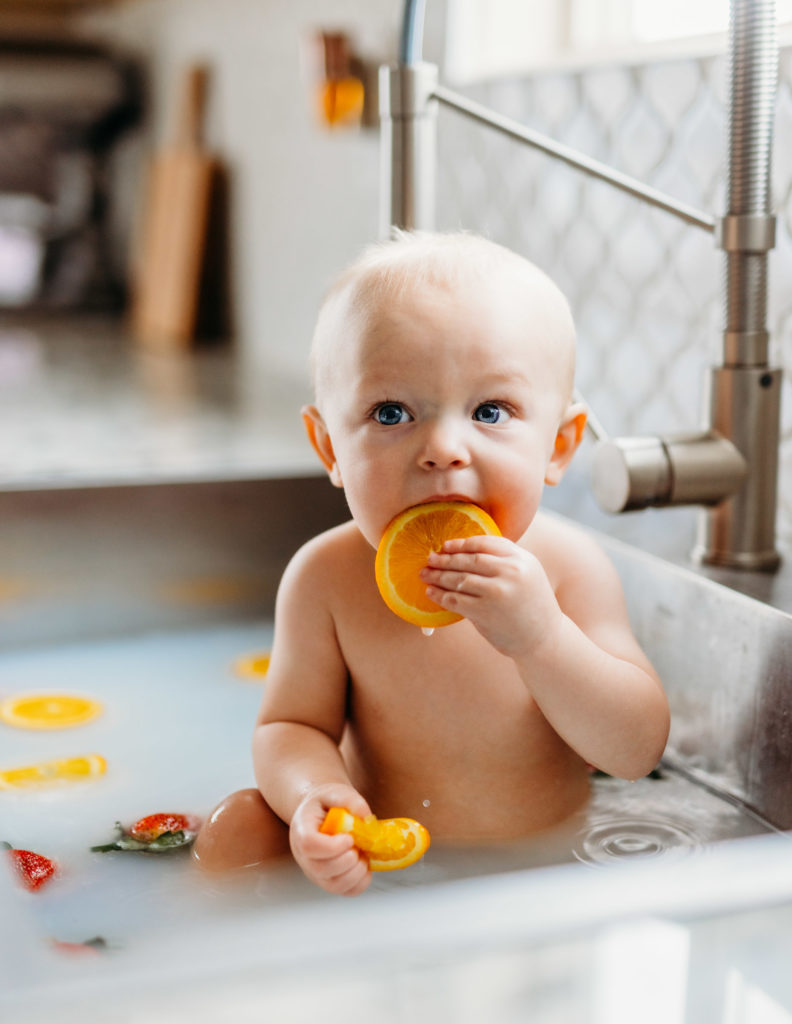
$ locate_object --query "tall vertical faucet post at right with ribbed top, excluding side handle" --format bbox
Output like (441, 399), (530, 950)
(695, 0), (782, 569)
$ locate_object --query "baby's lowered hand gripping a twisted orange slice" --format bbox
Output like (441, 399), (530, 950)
(289, 782), (371, 896)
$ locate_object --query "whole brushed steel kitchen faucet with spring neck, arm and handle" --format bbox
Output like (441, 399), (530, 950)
(380, 0), (782, 570)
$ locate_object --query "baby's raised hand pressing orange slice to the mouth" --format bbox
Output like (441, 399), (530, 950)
(421, 536), (560, 657)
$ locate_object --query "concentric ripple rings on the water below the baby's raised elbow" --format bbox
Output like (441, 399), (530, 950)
(573, 817), (705, 864)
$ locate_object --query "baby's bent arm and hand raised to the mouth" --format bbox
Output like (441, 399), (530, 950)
(423, 524), (669, 778)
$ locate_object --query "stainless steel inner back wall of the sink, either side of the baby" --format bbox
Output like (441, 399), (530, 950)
(0, 456), (792, 827)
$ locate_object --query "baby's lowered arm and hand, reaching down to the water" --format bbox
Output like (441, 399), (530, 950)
(253, 539), (371, 896)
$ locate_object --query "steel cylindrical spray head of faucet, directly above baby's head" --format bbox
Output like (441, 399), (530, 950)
(379, 63), (437, 238)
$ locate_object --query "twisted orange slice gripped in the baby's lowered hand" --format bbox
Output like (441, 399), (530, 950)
(319, 807), (429, 871)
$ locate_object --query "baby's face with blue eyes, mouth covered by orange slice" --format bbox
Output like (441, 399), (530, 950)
(311, 280), (571, 546)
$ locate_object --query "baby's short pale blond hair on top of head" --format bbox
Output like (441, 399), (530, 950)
(311, 230), (575, 400)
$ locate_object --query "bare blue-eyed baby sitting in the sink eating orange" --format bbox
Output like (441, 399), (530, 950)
(195, 232), (668, 895)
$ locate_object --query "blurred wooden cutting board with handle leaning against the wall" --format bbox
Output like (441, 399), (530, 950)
(131, 66), (216, 349)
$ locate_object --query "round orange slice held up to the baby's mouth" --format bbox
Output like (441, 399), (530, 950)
(374, 502), (500, 629)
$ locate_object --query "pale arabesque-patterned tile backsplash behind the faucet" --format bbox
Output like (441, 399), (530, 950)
(437, 48), (792, 544)
